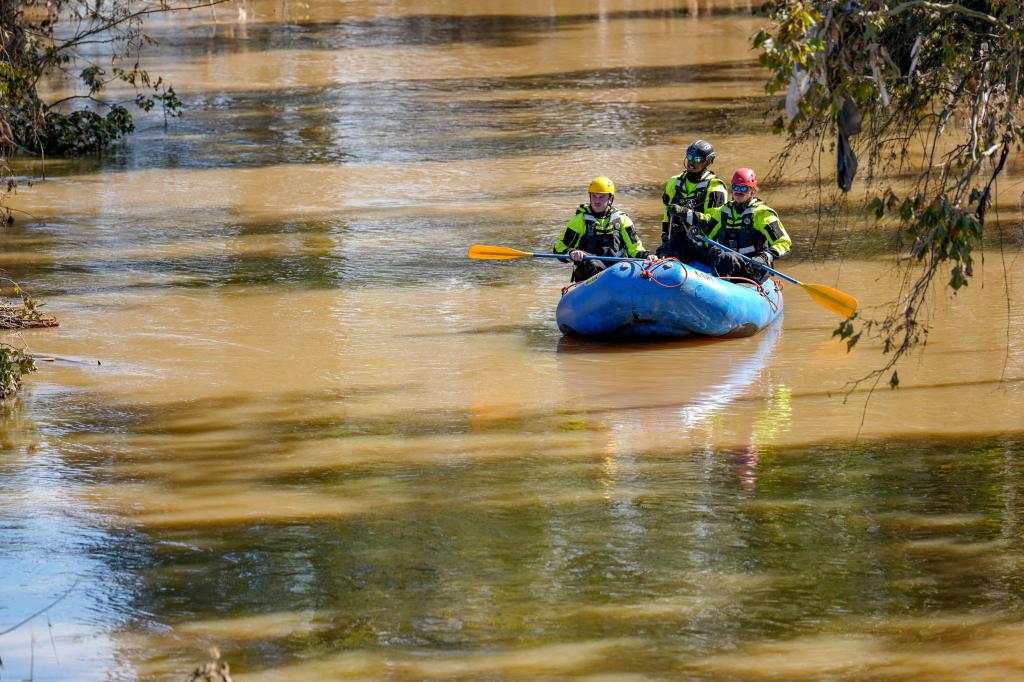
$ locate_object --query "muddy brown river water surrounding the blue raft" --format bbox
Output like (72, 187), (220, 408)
(0, 0), (1024, 680)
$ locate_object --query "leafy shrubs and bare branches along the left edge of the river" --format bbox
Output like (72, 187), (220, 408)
(0, 0), (218, 398)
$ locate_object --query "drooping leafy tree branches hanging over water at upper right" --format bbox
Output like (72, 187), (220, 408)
(754, 0), (1024, 386)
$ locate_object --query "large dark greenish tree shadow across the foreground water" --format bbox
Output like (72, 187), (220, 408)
(37, 395), (1024, 672)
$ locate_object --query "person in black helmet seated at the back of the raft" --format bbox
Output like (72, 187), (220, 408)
(656, 139), (729, 263)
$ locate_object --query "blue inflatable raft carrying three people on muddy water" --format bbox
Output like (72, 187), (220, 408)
(555, 260), (782, 339)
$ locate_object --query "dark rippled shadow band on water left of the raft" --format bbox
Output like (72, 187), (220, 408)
(3, 209), (552, 296)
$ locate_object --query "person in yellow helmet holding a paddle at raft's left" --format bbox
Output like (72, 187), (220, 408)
(554, 176), (649, 282)
